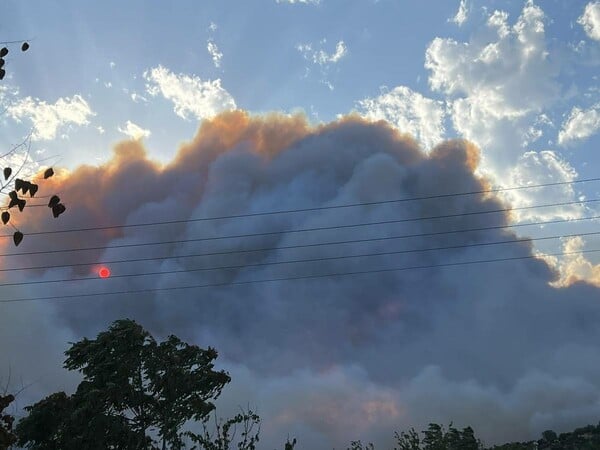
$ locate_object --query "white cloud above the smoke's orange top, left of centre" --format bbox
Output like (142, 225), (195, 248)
(144, 65), (236, 119)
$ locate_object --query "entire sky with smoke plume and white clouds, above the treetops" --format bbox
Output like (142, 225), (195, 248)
(0, 0), (600, 450)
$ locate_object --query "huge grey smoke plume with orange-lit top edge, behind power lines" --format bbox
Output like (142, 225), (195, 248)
(0, 111), (600, 450)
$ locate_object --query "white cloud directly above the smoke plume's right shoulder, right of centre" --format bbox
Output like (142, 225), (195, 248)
(358, 86), (445, 149)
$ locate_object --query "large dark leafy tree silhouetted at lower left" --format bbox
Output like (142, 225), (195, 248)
(17, 319), (231, 450)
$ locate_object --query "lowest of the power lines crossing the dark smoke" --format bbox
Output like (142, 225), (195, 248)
(0, 249), (600, 303)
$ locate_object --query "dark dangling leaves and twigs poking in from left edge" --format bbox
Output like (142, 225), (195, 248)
(0, 41), (66, 246)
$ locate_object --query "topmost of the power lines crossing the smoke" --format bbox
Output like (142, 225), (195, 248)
(0, 177), (600, 238)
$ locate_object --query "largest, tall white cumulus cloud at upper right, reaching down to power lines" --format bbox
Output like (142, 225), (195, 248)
(425, 1), (589, 225)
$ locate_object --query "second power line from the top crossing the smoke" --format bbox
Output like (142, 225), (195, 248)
(0, 199), (600, 257)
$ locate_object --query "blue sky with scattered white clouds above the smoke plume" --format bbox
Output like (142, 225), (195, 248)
(4, 0), (600, 268)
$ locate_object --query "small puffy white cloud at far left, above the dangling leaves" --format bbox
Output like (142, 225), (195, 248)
(7, 95), (95, 141)
